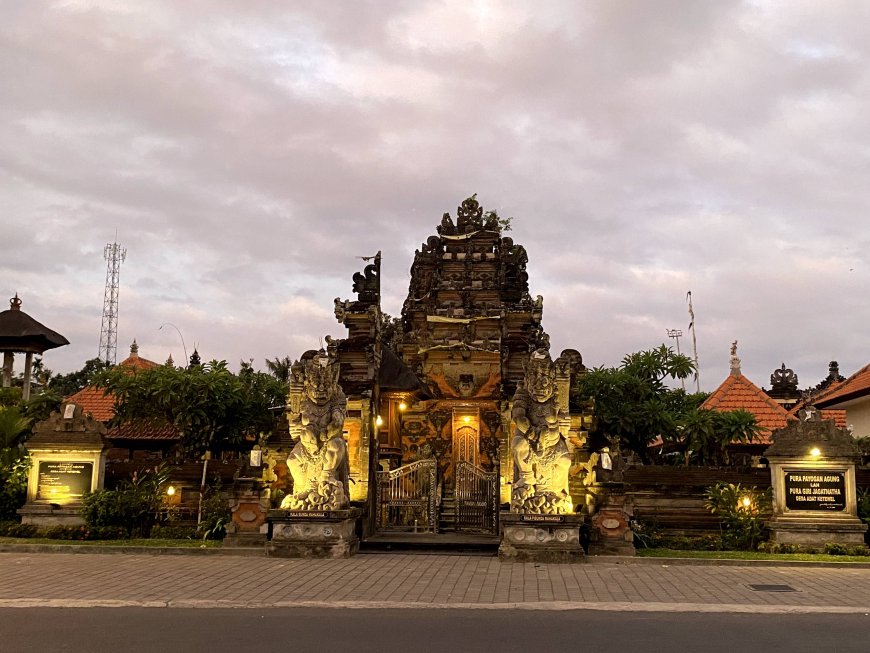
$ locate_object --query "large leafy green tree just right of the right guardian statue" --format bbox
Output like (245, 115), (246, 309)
(577, 345), (695, 462)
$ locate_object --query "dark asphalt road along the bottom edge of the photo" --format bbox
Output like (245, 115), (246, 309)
(0, 608), (870, 653)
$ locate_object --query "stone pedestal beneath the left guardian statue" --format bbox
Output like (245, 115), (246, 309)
(266, 508), (361, 558)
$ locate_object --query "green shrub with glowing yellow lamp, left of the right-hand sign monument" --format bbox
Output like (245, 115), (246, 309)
(705, 482), (772, 551)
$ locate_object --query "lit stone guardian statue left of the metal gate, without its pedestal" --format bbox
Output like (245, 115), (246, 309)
(281, 349), (349, 510)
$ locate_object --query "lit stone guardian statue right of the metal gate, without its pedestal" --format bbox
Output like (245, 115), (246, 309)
(511, 349), (573, 515)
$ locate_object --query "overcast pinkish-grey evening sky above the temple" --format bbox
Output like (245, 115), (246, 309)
(0, 0), (870, 390)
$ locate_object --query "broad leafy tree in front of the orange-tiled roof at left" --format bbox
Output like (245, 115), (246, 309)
(94, 361), (286, 456)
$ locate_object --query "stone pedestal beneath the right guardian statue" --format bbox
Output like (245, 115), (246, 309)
(498, 512), (585, 562)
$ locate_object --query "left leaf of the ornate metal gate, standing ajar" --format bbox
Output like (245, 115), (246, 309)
(375, 458), (438, 533)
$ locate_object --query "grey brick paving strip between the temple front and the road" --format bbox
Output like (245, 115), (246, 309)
(0, 553), (870, 613)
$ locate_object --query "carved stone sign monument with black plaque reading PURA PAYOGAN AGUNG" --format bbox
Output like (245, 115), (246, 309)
(764, 408), (867, 549)
